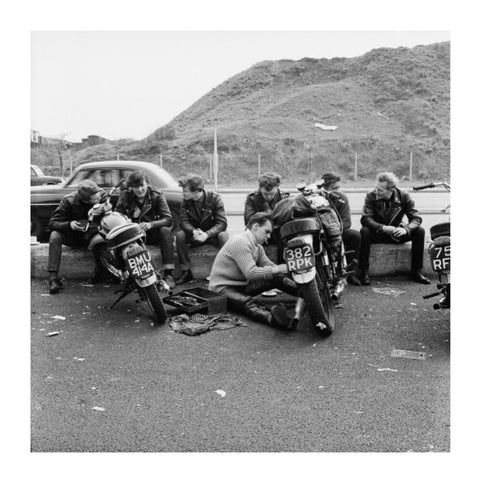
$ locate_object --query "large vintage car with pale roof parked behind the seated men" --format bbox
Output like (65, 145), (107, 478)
(30, 160), (182, 242)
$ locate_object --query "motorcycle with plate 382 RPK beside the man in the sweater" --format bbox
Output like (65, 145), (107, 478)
(272, 180), (353, 336)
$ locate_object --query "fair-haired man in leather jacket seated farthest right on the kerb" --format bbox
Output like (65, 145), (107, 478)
(359, 172), (430, 285)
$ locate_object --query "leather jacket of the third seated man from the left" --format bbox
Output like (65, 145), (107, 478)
(180, 189), (227, 238)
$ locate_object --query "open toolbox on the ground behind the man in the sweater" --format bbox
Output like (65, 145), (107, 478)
(163, 288), (227, 315)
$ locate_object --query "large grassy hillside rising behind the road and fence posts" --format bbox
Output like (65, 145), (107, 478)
(33, 42), (450, 184)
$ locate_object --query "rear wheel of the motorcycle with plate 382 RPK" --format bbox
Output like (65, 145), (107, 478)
(301, 273), (335, 337)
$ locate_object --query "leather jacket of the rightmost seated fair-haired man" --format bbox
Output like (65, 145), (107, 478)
(360, 188), (422, 234)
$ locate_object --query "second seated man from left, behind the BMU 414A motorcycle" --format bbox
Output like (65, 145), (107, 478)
(115, 171), (175, 288)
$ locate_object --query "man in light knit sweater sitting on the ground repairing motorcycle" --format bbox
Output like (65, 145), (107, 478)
(209, 212), (298, 330)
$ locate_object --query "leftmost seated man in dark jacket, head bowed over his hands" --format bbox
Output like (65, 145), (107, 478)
(47, 180), (106, 294)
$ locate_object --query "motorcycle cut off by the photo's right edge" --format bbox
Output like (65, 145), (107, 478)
(413, 182), (450, 310)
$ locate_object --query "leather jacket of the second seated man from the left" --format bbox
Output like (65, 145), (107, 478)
(115, 186), (173, 228)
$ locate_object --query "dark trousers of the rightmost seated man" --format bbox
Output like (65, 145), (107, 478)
(359, 226), (425, 271)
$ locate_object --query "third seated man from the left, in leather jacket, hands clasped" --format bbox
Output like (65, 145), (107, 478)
(175, 174), (228, 284)
